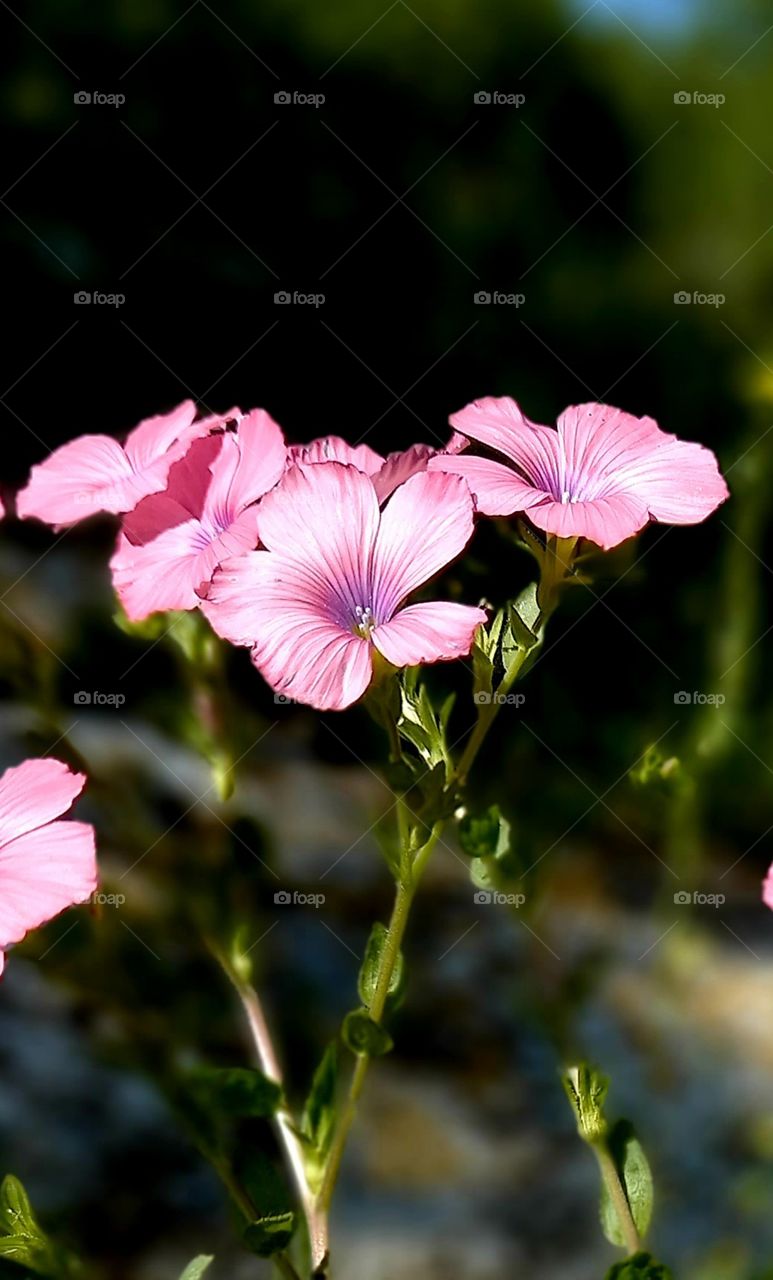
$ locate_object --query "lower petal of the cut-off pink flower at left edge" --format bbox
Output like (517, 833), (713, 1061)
(0, 819), (97, 947)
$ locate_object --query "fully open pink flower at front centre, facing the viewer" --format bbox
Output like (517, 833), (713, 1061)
(202, 462), (486, 710)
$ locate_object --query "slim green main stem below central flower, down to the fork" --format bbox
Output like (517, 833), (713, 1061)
(316, 822), (443, 1215)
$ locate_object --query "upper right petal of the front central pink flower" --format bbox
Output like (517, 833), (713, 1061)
(371, 471), (474, 622)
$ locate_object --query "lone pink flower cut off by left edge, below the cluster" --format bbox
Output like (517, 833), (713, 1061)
(0, 759), (97, 973)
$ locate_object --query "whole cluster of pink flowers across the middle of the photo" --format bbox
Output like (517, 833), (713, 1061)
(17, 397), (727, 709)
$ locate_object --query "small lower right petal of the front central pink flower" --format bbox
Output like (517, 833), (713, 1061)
(372, 602), (486, 667)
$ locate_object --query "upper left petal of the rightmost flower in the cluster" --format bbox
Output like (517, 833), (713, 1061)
(448, 396), (559, 494)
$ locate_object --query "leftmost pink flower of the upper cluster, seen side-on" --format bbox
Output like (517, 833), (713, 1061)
(17, 401), (238, 529)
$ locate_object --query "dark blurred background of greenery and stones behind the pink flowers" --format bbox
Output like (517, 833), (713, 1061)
(0, 0), (773, 1280)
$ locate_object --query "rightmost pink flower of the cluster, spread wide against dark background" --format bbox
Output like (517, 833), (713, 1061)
(429, 396), (728, 550)
